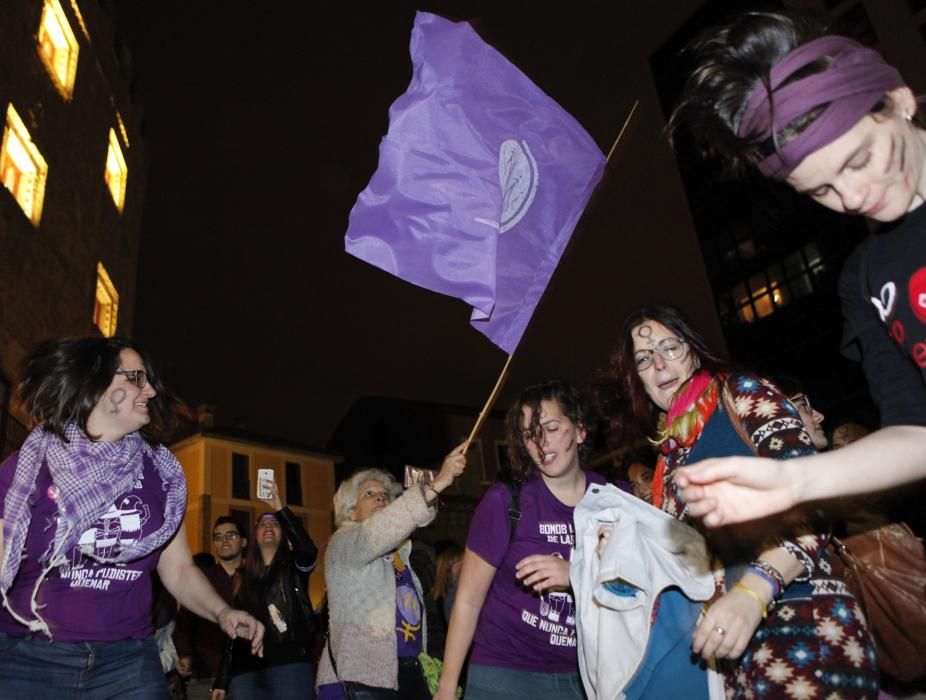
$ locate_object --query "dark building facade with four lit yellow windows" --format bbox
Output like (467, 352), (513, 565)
(0, 0), (146, 454)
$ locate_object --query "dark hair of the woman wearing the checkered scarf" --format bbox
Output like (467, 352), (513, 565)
(16, 336), (181, 444)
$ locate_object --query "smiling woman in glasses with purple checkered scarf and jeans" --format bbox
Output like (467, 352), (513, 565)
(0, 338), (263, 700)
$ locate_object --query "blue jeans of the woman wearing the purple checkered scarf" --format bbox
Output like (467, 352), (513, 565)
(0, 633), (167, 700)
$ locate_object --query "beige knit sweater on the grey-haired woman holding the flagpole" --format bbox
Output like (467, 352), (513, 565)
(317, 486), (436, 690)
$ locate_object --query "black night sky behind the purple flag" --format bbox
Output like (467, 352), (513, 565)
(117, 0), (717, 447)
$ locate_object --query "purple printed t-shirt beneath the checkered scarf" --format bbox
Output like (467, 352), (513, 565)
(0, 455), (167, 642)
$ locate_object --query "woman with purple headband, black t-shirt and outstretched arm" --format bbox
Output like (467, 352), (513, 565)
(670, 12), (926, 527)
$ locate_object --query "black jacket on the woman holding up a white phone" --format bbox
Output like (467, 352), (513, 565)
(215, 507), (318, 690)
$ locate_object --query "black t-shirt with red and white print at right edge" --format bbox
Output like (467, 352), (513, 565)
(839, 206), (926, 426)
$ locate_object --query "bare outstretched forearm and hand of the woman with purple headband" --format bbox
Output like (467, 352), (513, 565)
(675, 425), (926, 527)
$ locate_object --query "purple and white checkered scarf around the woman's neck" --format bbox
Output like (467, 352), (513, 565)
(0, 423), (186, 598)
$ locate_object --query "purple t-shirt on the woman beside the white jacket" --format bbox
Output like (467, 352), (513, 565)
(466, 472), (605, 673)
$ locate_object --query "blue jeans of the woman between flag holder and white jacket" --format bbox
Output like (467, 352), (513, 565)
(464, 664), (585, 700)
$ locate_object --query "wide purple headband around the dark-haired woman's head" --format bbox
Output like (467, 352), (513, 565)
(736, 36), (904, 180)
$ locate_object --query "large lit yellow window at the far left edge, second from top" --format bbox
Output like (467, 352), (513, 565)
(0, 105), (48, 226)
